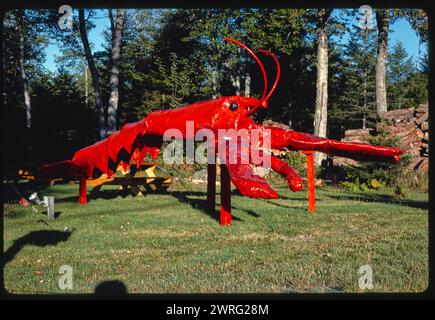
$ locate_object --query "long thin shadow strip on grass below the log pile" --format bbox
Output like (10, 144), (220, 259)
(324, 193), (429, 209)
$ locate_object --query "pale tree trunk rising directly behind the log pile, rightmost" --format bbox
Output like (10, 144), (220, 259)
(376, 9), (390, 115)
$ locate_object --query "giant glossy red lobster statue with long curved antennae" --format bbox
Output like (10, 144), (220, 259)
(40, 38), (403, 220)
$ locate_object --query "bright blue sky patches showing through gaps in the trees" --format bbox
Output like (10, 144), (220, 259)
(44, 11), (427, 71)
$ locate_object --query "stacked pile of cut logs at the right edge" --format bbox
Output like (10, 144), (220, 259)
(334, 105), (429, 172)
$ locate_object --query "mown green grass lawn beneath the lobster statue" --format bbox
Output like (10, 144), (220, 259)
(3, 179), (429, 294)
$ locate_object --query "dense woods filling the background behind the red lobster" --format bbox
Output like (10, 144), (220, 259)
(2, 9), (428, 175)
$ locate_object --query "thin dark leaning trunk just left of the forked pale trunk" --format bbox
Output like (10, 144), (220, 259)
(78, 9), (106, 140)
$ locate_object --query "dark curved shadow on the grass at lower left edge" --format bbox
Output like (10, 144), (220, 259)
(3, 230), (71, 267)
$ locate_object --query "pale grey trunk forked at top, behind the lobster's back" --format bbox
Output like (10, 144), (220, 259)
(107, 9), (125, 134)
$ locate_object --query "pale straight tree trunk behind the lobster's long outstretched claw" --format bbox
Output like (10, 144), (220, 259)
(314, 9), (332, 165)
